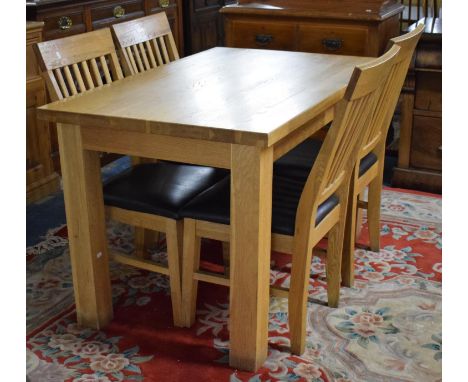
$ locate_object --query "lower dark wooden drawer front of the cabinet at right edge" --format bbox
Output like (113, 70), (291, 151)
(411, 116), (442, 171)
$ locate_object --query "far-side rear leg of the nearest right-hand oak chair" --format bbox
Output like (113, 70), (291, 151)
(326, 221), (346, 308)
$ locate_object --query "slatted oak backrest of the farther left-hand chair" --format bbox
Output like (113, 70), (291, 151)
(112, 12), (179, 76)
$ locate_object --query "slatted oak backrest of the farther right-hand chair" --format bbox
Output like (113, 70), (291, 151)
(359, 24), (424, 158)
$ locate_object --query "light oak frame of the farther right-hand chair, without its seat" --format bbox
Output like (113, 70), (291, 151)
(342, 25), (424, 286)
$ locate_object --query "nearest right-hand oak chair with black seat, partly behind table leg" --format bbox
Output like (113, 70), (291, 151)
(181, 43), (399, 354)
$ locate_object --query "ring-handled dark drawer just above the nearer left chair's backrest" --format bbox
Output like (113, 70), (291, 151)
(41, 7), (86, 40)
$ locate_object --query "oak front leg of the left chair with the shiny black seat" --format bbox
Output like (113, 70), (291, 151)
(166, 220), (184, 327)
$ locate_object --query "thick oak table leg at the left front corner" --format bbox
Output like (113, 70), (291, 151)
(57, 124), (112, 329)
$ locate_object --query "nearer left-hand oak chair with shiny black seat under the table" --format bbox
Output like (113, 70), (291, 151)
(34, 29), (227, 326)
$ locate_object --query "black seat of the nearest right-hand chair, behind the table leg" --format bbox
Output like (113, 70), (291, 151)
(180, 176), (339, 236)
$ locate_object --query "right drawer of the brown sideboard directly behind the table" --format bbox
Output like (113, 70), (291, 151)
(298, 24), (369, 56)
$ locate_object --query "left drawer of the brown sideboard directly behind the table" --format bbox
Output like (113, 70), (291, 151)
(232, 20), (295, 50)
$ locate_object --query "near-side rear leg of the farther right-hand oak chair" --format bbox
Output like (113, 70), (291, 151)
(340, 168), (359, 287)
